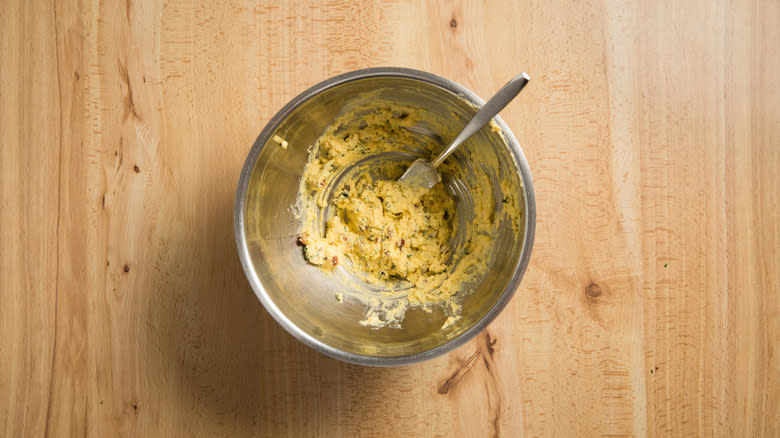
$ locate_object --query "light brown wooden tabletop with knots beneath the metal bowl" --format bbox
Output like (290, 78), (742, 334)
(0, 0), (780, 437)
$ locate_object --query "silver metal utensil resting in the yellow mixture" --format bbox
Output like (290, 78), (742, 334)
(399, 72), (531, 189)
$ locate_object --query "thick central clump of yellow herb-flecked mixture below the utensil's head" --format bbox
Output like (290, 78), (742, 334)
(302, 175), (455, 287)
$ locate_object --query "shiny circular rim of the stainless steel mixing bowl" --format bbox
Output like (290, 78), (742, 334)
(233, 67), (536, 366)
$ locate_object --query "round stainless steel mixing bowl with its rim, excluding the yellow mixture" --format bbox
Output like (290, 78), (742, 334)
(234, 68), (536, 366)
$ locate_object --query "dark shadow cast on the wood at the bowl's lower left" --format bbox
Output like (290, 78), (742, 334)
(147, 168), (409, 436)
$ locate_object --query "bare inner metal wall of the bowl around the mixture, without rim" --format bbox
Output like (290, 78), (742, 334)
(243, 77), (528, 357)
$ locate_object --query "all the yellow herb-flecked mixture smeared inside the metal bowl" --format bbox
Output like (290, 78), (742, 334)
(298, 98), (516, 327)
